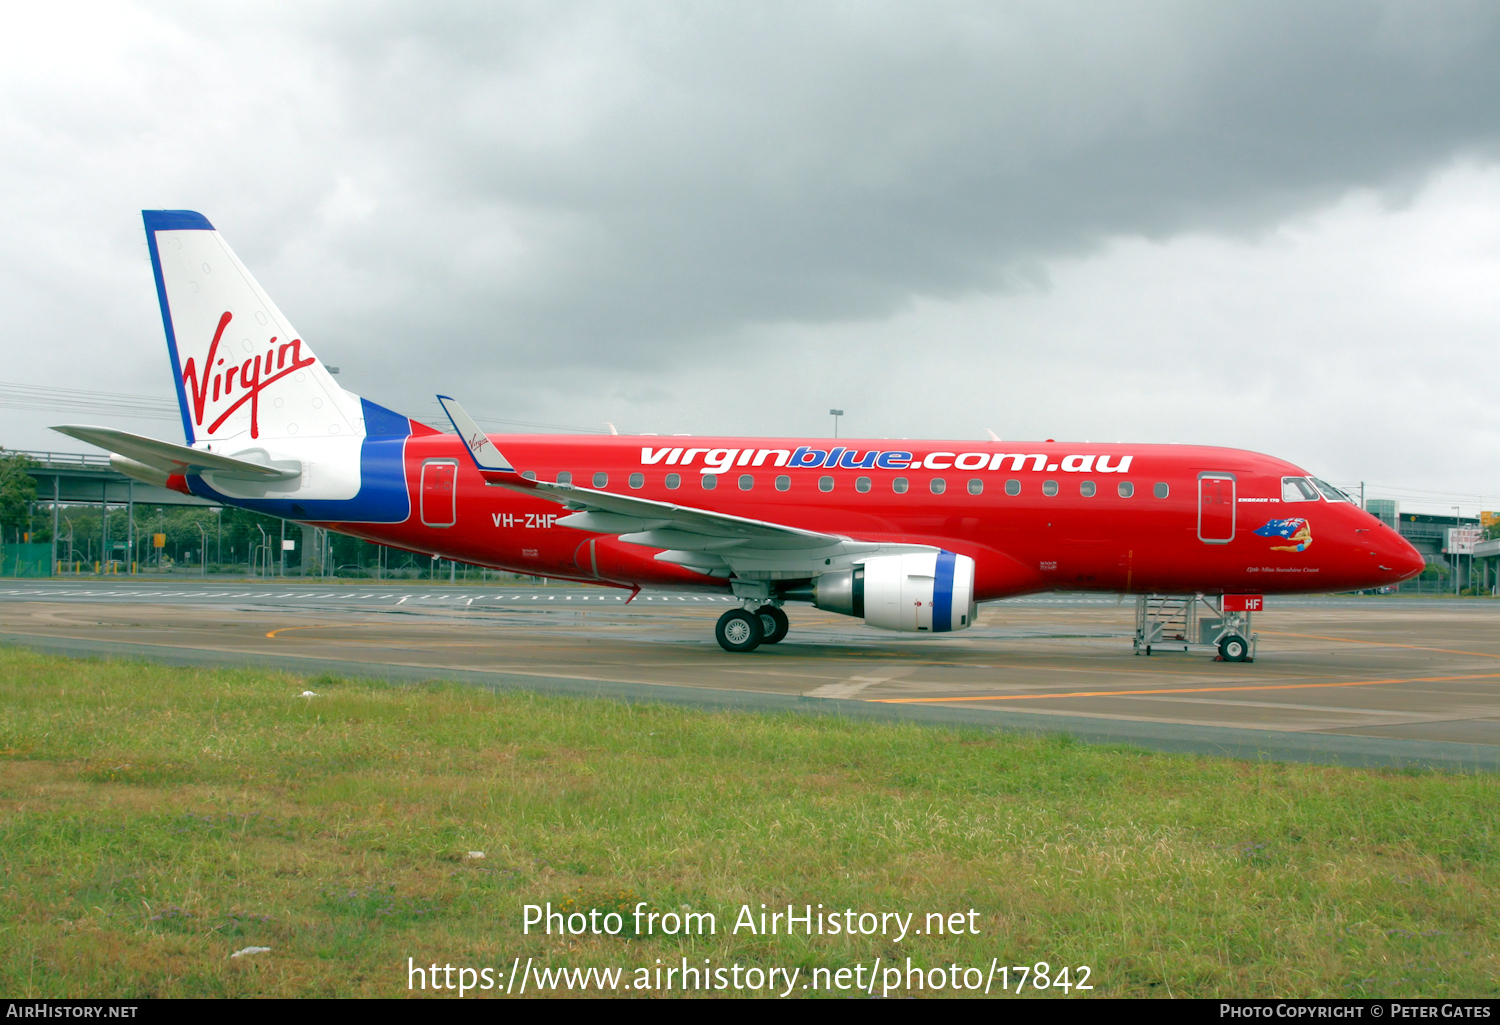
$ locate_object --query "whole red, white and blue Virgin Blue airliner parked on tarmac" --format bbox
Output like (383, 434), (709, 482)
(56, 210), (1424, 660)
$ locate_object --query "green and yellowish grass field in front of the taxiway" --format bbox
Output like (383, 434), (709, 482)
(0, 648), (1500, 999)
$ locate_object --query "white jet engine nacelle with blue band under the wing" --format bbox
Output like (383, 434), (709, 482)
(812, 552), (978, 633)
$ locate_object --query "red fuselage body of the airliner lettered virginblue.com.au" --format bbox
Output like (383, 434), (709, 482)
(313, 426), (1425, 600)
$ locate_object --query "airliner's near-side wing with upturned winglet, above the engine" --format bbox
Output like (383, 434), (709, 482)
(443, 399), (938, 579)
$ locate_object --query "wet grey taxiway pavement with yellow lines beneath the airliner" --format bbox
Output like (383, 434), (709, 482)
(0, 579), (1500, 770)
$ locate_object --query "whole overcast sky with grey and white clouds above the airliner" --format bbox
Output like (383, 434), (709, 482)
(0, 0), (1500, 512)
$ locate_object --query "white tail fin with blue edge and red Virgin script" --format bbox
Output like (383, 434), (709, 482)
(141, 210), (365, 449)
